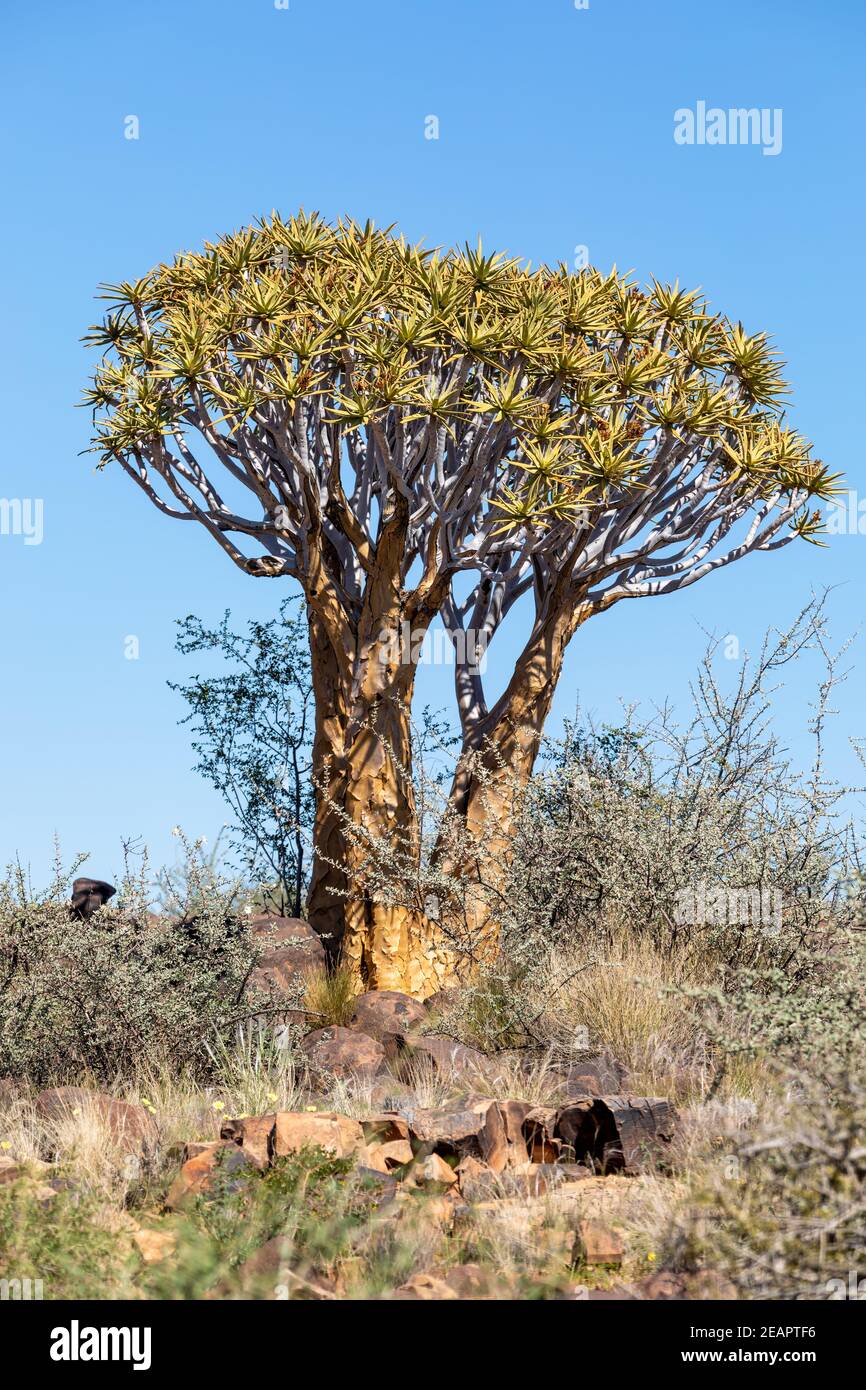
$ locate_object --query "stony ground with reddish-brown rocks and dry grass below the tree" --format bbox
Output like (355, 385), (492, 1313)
(0, 961), (731, 1300)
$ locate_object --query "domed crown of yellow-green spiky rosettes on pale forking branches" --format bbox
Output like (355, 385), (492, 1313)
(86, 213), (837, 717)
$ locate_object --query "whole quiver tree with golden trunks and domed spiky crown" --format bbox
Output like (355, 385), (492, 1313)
(86, 214), (834, 994)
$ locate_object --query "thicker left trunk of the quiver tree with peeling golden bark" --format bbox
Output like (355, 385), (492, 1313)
(307, 525), (453, 997)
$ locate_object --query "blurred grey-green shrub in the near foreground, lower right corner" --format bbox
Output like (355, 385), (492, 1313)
(667, 935), (866, 1300)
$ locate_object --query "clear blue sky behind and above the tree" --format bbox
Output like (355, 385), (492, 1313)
(0, 0), (866, 881)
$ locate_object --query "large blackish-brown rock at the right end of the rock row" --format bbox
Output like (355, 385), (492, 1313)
(555, 1095), (676, 1175)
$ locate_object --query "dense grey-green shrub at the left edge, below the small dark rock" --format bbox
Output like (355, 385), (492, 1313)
(0, 847), (268, 1084)
